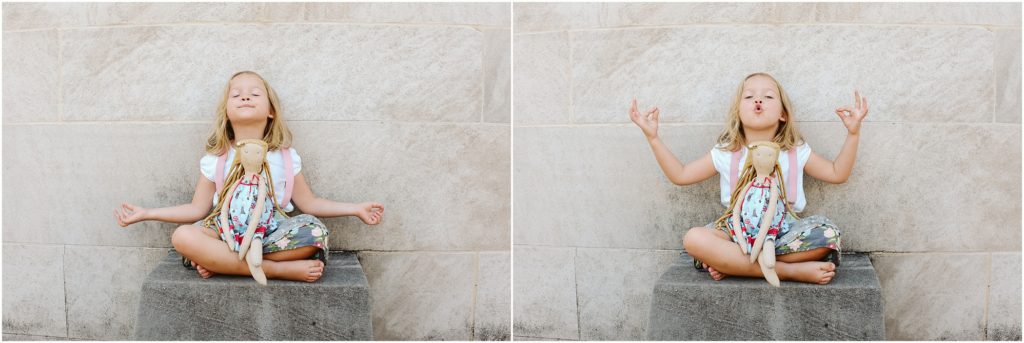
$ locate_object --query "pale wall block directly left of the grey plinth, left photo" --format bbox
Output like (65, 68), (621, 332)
(65, 246), (167, 340)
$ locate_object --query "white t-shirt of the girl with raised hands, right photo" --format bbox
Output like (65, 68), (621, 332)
(711, 142), (811, 213)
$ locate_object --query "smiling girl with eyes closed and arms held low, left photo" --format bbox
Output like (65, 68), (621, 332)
(114, 72), (384, 283)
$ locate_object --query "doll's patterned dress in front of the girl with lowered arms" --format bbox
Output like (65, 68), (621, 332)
(216, 174), (278, 251)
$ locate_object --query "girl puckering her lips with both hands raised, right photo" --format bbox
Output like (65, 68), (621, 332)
(630, 73), (867, 285)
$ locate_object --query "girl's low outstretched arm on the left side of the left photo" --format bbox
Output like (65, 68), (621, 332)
(114, 175), (216, 227)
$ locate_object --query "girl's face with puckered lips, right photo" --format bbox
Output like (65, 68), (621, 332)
(739, 75), (785, 130)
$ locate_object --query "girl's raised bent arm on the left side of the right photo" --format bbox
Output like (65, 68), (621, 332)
(630, 99), (716, 185)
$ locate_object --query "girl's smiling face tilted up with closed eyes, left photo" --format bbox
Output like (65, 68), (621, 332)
(227, 74), (273, 125)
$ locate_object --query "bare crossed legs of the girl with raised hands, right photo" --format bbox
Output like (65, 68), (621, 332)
(683, 227), (836, 285)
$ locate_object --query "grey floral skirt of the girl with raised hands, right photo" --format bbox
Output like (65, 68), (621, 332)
(705, 215), (842, 266)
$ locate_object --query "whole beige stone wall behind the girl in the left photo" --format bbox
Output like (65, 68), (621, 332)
(3, 3), (511, 340)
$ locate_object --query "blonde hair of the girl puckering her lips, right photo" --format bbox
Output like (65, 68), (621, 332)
(718, 73), (804, 152)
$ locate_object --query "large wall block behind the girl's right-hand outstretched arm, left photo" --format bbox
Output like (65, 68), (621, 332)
(293, 123), (511, 250)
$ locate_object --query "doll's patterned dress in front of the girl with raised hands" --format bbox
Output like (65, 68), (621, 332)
(726, 177), (792, 254)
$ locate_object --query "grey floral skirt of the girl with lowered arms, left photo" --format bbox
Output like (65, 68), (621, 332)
(196, 212), (330, 263)
